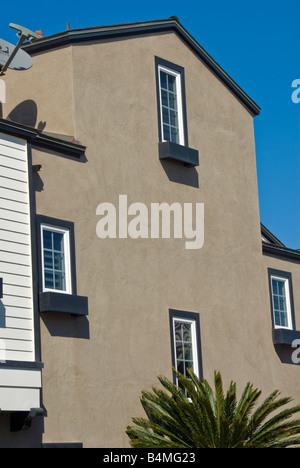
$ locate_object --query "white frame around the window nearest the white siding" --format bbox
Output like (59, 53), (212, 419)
(40, 223), (72, 294)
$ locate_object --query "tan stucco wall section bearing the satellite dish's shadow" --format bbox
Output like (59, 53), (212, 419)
(2, 48), (74, 136)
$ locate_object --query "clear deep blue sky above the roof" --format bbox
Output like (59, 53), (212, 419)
(0, 0), (300, 249)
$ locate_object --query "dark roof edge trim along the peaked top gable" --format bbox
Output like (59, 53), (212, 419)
(23, 16), (260, 116)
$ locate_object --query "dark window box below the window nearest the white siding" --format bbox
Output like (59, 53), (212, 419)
(39, 291), (88, 316)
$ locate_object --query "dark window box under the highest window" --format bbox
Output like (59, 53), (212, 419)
(158, 141), (199, 167)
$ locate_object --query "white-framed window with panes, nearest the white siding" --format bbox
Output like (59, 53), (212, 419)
(41, 224), (72, 294)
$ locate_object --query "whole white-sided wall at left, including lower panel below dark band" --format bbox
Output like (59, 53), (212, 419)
(0, 133), (41, 411)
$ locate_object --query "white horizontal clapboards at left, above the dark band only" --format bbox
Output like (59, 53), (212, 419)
(0, 134), (34, 362)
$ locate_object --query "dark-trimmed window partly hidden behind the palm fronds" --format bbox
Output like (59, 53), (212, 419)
(169, 310), (202, 384)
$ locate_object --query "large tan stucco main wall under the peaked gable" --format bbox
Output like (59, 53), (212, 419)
(1, 29), (300, 447)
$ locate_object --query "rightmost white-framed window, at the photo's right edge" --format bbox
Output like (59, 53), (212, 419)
(269, 269), (295, 330)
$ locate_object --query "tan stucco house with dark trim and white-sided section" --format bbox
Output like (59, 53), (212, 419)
(0, 17), (300, 447)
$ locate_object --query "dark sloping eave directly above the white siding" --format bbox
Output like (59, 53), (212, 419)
(0, 119), (86, 158)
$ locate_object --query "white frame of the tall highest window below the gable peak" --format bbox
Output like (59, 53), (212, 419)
(158, 65), (185, 146)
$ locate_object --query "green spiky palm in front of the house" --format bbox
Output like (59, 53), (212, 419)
(126, 369), (300, 449)
